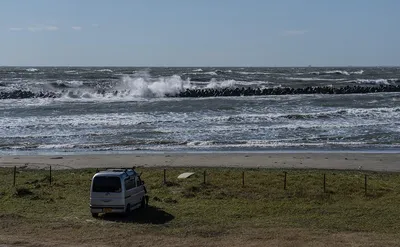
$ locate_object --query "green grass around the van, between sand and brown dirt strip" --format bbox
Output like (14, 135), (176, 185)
(0, 168), (400, 237)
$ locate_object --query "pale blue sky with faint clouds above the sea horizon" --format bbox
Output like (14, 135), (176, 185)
(0, 0), (400, 66)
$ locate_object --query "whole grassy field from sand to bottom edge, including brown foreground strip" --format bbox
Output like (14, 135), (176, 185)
(0, 168), (400, 246)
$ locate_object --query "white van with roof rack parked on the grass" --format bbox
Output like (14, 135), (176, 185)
(90, 169), (147, 217)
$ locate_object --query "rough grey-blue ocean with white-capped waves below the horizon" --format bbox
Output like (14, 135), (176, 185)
(0, 67), (400, 155)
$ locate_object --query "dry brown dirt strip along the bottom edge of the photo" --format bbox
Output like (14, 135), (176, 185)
(0, 229), (400, 247)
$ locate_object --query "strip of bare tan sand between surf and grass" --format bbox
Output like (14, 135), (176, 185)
(0, 153), (400, 172)
